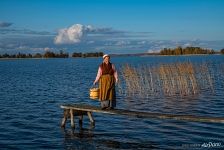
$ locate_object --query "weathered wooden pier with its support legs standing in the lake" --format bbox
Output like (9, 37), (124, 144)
(61, 104), (224, 128)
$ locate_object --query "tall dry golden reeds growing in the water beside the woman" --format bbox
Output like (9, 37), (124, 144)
(118, 62), (214, 98)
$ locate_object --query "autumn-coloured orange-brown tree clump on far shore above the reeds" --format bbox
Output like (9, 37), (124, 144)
(160, 46), (215, 55)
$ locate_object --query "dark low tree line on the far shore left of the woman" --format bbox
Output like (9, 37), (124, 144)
(0, 51), (103, 58)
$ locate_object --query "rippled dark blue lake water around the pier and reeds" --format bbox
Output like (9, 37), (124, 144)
(0, 55), (224, 150)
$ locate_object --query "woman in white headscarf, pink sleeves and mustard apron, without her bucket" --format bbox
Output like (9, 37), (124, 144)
(93, 54), (118, 109)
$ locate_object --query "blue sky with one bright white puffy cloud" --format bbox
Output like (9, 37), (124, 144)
(0, 0), (224, 53)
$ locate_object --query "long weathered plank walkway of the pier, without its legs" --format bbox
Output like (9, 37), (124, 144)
(61, 104), (224, 123)
